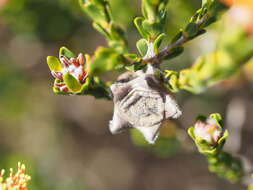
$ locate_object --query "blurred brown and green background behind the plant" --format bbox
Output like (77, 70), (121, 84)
(0, 0), (253, 190)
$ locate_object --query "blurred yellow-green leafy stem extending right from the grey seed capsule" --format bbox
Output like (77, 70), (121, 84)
(166, 28), (253, 93)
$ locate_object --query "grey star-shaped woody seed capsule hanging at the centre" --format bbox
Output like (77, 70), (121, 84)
(110, 67), (181, 143)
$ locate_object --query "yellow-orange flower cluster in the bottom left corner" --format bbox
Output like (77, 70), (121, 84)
(0, 162), (31, 190)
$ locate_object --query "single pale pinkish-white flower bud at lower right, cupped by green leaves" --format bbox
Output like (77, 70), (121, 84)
(194, 118), (223, 146)
